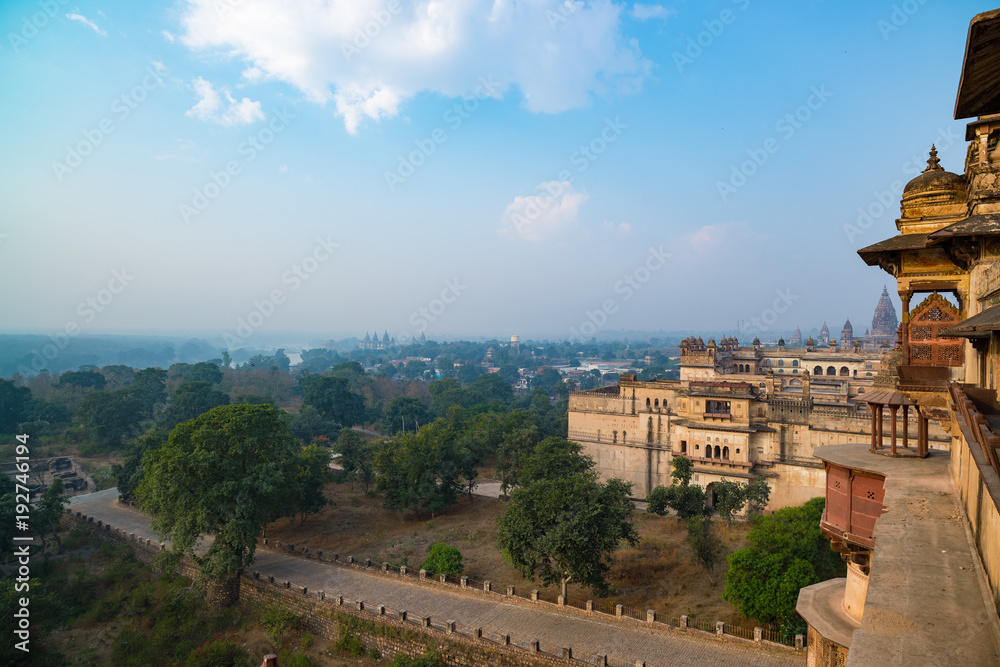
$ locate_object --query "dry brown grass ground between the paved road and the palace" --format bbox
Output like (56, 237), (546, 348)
(267, 482), (749, 622)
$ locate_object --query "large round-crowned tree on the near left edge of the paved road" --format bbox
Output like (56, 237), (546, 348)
(137, 405), (298, 605)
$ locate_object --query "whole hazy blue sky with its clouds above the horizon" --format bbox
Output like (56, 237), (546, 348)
(0, 0), (994, 347)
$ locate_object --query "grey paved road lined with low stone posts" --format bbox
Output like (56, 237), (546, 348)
(71, 489), (806, 667)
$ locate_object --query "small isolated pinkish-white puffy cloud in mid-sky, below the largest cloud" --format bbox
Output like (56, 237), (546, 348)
(500, 181), (588, 242)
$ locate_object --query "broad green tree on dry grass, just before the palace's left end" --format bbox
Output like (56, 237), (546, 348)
(497, 475), (639, 599)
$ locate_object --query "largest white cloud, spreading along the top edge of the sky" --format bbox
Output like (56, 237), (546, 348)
(181, 0), (651, 132)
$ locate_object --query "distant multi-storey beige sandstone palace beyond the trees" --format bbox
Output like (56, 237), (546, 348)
(569, 290), (948, 508)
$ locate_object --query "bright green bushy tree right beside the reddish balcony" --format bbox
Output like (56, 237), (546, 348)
(723, 498), (846, 624)
